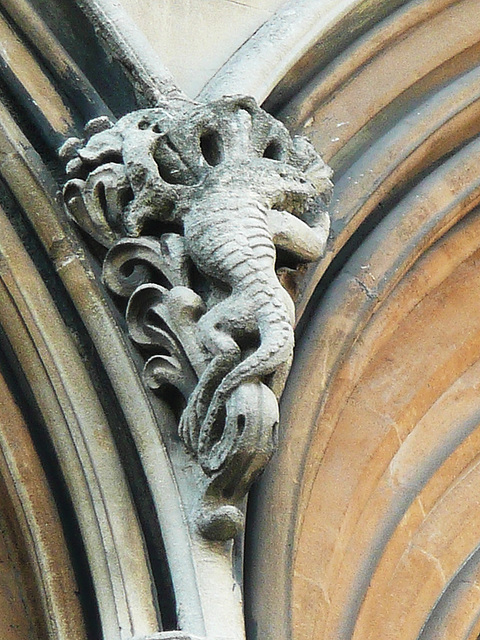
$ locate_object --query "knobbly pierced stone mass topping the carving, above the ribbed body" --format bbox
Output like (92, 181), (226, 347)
(60, 96), (332, 247)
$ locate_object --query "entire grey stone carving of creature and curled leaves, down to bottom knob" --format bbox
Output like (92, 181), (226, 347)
(62, 96), (331, 539)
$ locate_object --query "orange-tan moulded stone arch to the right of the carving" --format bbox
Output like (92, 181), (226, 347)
(247, 2), (480, 640)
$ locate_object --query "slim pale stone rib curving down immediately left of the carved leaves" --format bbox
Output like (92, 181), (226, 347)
(0, 99), (204, 637)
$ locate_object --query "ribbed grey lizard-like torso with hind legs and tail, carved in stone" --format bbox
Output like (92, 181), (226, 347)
(180, 190), (294, 449)
